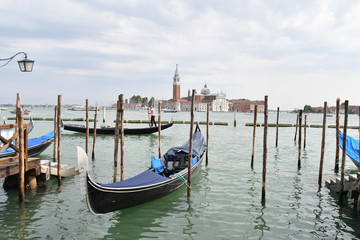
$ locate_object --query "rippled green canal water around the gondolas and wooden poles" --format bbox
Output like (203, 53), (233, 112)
(0, 108), (360, 240)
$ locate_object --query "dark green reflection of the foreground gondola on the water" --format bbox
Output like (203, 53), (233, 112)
(100, 168), (211, 239)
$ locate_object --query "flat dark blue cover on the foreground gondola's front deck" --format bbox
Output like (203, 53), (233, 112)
(100, 170), (169, 188)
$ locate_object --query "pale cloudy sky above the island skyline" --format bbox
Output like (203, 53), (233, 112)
(0, 0), (360, 109)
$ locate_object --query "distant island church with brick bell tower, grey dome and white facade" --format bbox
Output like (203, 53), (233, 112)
(161, 64), (229, 112)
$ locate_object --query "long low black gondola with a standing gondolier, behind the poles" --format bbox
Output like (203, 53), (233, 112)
(64, 122), (173, 135)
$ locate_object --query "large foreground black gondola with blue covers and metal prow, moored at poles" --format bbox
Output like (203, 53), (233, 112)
(78, 126), (205, 214)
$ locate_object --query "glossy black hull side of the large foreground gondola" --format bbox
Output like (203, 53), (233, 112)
(86, 160), (201, 214)
